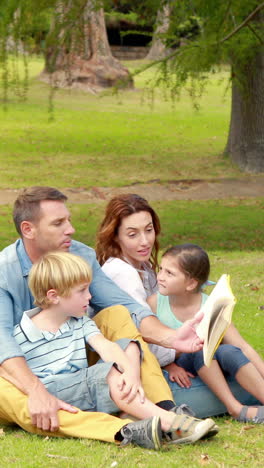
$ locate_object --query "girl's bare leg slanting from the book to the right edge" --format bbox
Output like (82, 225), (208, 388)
(223, 323), (264, 378)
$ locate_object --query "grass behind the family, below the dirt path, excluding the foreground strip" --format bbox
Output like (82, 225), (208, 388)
(0, 199), (264, 355)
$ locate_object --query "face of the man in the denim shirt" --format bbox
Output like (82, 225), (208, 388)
(32, 200), (75, 256)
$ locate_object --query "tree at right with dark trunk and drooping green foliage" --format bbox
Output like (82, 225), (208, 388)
(146, 0), (264, 172)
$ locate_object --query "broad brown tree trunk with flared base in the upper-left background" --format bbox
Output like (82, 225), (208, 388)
(40, 0), (133, 92)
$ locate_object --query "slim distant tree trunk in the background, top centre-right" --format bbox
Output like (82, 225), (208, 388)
(146, 3), (171, 60)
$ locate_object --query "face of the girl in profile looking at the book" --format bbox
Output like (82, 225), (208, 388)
(157, 255), (194, 296)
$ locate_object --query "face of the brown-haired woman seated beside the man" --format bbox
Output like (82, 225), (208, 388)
(116, 211), (155, 268)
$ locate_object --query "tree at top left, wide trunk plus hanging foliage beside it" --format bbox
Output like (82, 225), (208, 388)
(0, 0), (133, 96)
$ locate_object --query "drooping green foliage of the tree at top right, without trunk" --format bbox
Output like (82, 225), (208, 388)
(141, 0), (264, 101)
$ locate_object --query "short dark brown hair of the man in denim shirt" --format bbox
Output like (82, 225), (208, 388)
(13, 186), (67, 236)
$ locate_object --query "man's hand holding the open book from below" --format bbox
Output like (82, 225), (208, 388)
(171, 312), (203, 353)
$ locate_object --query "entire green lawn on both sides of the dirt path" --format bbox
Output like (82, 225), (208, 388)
(0, 58), (264, 468)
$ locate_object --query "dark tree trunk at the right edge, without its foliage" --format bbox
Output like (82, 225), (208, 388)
(225, 50), (264, 173)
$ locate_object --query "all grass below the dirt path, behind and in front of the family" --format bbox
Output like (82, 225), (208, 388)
(0, 199), (264, 468)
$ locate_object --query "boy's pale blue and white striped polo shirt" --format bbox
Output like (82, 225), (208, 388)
(13, 307), (100, 379)
